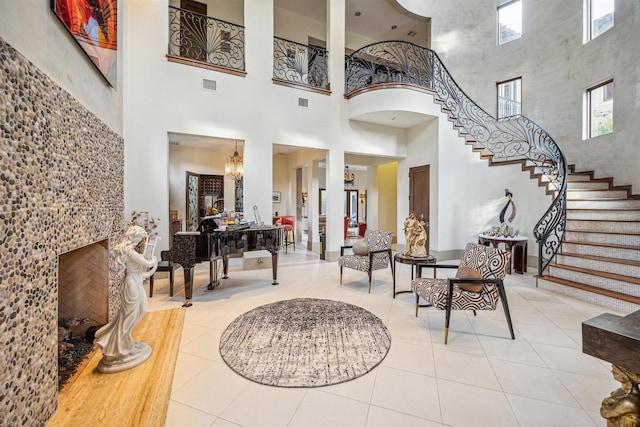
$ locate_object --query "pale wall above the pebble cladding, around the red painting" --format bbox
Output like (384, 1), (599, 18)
(0, 0), (126, 134)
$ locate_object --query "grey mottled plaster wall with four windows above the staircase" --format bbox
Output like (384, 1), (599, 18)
(398, 0), (640, 194)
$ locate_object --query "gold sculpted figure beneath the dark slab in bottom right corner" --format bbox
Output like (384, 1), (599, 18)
(600, 365), (640, 427)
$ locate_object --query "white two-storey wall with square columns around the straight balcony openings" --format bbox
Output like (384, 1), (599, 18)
(121, 0), (404, 253)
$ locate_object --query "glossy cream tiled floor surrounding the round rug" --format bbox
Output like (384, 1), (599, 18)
(149, 245), (619, 427)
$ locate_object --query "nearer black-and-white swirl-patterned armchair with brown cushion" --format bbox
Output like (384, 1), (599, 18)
(411, 243), (515, 344)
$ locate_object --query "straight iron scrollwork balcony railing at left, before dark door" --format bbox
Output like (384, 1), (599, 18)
(169, 6), (244, 71)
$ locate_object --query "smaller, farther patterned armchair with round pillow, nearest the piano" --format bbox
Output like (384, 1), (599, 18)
(338, 230), (395, 293)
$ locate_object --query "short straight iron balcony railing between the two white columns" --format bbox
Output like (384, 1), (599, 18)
(273, 37), (329, 89)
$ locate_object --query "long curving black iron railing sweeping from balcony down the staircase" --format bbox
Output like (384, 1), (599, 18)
(345, 41), (568, 275)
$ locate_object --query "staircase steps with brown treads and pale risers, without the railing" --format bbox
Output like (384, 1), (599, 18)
(537, 165), (640, 313)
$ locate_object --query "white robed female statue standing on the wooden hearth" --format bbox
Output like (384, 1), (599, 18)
(94, 225), (158, 373)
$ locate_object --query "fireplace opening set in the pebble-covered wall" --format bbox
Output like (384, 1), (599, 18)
(58, 240), (109, 390)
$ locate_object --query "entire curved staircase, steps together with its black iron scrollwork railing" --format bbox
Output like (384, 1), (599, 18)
(345, 41), (640, 313)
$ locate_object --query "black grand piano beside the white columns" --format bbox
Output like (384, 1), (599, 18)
(161, 217), (284, 307)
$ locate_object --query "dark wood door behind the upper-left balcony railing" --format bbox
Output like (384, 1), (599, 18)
(180, 0), (207, 62)
